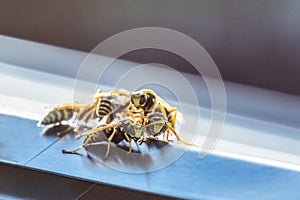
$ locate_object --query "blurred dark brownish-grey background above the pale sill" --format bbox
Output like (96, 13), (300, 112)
(0, 0), (300, 95)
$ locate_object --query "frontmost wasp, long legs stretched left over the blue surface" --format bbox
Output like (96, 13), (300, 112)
(62, 118), (145, 158)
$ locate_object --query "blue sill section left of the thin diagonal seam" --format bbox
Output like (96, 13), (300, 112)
(0, 114), (58, 165)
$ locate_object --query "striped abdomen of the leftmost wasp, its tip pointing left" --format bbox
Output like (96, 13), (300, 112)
(40, 109), (73, 125)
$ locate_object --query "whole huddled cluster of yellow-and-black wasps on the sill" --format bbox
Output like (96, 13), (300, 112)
(38, 89), (188, 157)
